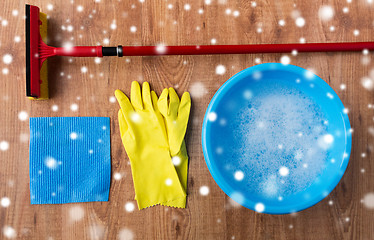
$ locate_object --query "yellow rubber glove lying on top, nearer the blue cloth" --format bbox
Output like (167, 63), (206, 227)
(115, 82), (186, 209)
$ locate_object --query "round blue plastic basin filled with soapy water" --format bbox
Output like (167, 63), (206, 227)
(202, 63), (352, 214)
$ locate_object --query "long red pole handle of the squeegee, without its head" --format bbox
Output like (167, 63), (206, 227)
(55, 42), (374, 57)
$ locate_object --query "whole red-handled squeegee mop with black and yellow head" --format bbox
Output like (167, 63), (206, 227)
(26, 5), (374, 99)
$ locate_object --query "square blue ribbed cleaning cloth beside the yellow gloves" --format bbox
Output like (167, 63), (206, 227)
(30, 117), (111, 204)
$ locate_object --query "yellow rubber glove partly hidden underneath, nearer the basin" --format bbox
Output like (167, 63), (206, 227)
(157, 88), (191, 208)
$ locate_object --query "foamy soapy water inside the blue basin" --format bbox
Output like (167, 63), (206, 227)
(225, 84), (333, 201)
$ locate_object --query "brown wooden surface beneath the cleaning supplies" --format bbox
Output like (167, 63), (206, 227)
(0, 0), (374, 240)
